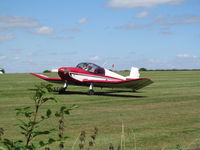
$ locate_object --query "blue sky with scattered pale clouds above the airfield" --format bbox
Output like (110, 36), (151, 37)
(0, 0), (200, 73)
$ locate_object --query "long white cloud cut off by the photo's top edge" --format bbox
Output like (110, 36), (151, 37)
(107, 0), (183, 8)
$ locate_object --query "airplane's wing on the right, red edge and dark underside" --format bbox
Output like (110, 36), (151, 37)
(83, 78), (153, 90)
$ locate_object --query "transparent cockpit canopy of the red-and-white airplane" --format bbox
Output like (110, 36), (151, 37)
(76, 63), (105, 75)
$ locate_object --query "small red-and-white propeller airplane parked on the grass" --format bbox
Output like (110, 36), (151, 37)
(31, 62), (153, 95)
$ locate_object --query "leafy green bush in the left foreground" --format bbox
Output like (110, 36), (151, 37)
(0, 84), (77, 150)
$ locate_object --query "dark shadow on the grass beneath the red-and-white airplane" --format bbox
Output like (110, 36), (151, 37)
(55, 91), (146, 98)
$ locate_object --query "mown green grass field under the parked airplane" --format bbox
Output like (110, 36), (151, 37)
(0, 71), (200, 150)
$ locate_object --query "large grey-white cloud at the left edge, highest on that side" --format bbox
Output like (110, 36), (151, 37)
(0, 14), (38, 30)
